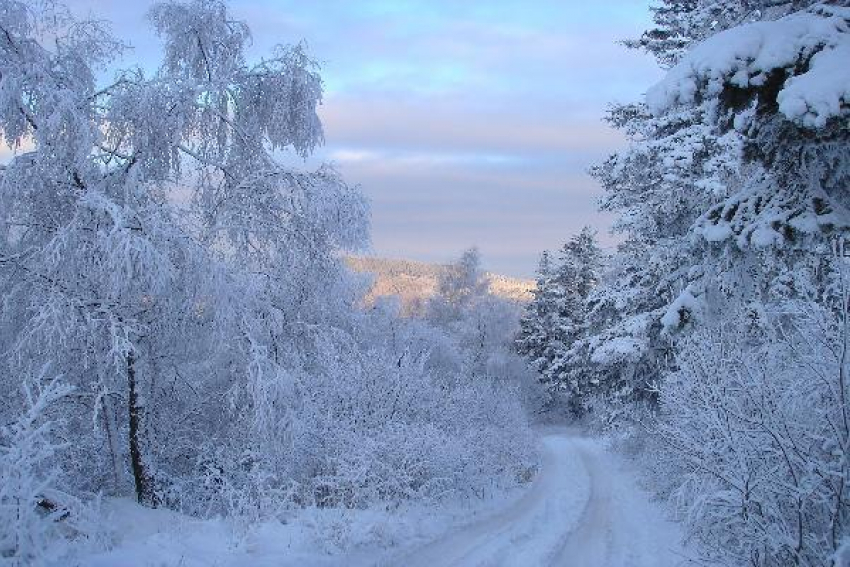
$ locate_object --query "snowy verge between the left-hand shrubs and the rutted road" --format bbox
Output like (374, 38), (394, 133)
(69, 489), (526, 567)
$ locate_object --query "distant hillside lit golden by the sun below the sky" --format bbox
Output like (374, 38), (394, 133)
(346, 257), (534, 313)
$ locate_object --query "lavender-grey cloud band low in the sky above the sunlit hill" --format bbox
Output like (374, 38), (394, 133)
(328, 141), (611, 275)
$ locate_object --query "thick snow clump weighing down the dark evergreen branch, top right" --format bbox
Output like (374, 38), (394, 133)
(646, 5), (850, 127)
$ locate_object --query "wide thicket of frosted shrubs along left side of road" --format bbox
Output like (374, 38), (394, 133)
(163, 286), (533, 521)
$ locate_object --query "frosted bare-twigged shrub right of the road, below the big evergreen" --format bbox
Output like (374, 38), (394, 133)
(653, 298), (850, 567)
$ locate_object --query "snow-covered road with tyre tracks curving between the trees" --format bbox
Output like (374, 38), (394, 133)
(392, 432), (685, 567)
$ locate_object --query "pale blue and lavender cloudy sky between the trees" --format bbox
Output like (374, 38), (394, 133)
(68, 0), (661, 277)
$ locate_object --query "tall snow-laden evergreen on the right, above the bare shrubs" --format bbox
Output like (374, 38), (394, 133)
(590, 1), (847, 418)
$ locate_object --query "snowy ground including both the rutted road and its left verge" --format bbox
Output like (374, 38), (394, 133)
(73, 431), (687, 567)
